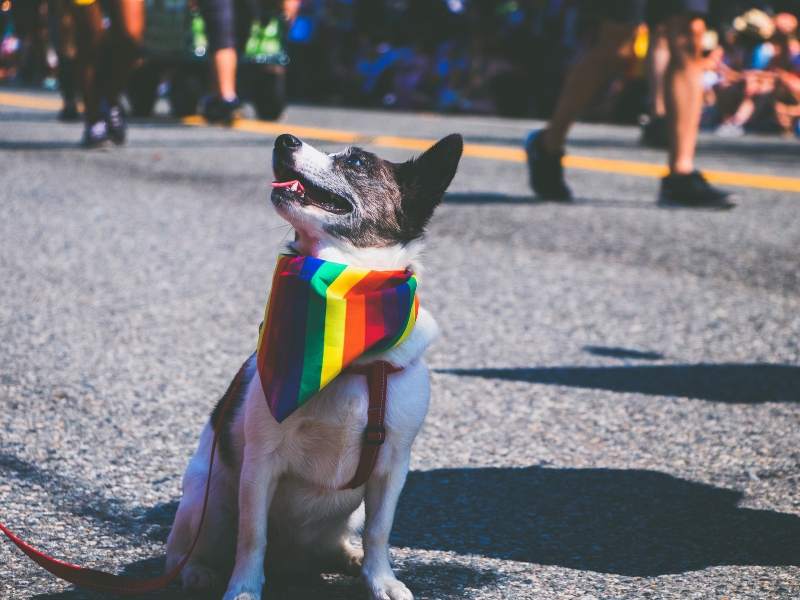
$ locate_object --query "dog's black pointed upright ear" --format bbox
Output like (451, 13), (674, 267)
(397, 133), (464, 237)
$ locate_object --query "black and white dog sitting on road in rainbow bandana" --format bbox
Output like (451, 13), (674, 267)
(167, 134), (463, 600)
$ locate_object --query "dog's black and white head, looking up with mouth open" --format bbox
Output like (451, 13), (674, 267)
(272, 134), (463, 264)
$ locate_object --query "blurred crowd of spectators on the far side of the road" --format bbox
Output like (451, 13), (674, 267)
(0, 0), (800, 135)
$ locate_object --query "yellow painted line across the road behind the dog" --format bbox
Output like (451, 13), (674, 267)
(6, 93), (800, 193)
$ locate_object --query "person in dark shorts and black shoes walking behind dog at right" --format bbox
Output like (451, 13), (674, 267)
(525, 0), (732, 208)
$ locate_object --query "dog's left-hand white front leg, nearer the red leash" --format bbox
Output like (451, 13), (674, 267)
(223, 443), (278, 600)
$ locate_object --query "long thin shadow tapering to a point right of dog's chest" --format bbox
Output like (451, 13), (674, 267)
(435, 363), (800, 404)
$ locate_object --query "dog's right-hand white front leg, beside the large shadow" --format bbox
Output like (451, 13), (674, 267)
(362, 456), (414, 600)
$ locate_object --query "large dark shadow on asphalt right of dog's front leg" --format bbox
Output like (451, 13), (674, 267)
(393, 467), (800, 577)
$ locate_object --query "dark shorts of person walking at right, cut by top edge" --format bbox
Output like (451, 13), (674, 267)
(582, 0), (710, 25)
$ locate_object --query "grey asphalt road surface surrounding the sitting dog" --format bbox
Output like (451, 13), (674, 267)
(0, 91), (800, 600)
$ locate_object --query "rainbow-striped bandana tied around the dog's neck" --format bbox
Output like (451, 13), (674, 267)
(257, 255), (419, 422)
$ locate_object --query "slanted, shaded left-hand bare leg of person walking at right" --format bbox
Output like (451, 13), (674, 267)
(542, 21), (636, 154)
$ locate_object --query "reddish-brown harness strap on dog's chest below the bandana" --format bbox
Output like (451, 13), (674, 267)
(341, 360), (403, 490)
